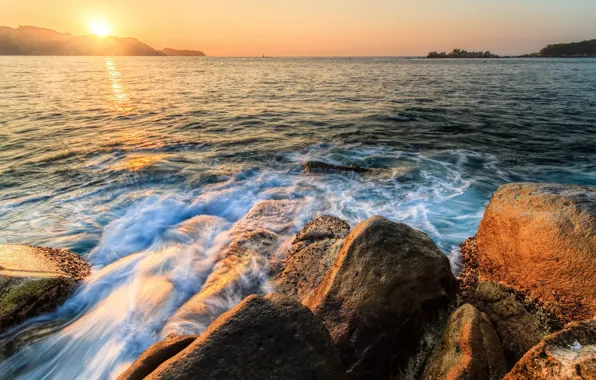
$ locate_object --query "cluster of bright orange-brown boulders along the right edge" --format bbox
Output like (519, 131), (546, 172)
(459, 183), (596, 379)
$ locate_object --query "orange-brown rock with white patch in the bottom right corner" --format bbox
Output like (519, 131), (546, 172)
(504, 320), (596, 380)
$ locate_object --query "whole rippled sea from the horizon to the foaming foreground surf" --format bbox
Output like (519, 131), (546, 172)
(0, 57), (596, 379)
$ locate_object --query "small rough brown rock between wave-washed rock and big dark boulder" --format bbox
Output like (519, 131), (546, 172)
(273, 216), (350, 299)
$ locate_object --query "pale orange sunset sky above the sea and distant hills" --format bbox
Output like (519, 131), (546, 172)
(0, 0), (596, 56)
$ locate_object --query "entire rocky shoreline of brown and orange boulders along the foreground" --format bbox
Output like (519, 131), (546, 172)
(0, 182), (596, 380)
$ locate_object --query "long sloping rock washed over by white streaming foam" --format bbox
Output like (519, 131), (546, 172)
(162, 200), (298, 337)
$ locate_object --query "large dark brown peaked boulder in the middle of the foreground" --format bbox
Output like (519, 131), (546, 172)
(303, 216), (457, 379)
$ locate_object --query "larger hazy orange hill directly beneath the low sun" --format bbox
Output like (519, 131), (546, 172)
(0, 26), (204, 56)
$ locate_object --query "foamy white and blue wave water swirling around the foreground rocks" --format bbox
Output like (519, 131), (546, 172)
(0, 144), (512, 379)
